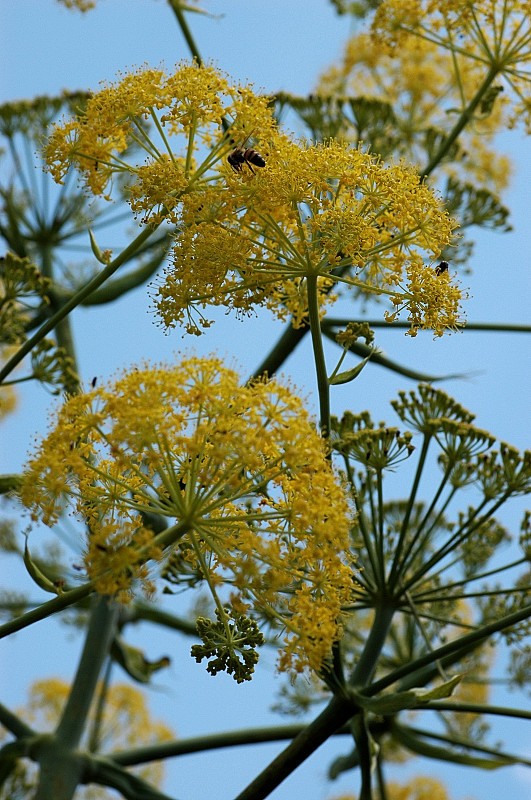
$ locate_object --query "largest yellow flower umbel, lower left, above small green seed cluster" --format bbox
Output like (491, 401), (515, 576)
(21, 358), (353, 669)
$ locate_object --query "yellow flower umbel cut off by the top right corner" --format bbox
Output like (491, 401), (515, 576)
(373, 0), (531, 130)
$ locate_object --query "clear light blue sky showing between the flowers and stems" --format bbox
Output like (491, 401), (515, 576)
(0, 0), (531, 800)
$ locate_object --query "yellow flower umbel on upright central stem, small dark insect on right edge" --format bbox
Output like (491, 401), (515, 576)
(153, 134), (460, 333)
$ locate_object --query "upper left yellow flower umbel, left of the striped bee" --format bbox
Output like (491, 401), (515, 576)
(45, 63), (274, 208)
